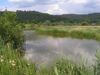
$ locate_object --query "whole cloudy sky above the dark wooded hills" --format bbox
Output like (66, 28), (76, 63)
(0, 0), (100, 14)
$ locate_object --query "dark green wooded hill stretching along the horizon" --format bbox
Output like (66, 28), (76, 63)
(0, 10), (100, 25)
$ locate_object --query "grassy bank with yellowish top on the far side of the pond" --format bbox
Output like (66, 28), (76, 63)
(36, 26), (100, 41)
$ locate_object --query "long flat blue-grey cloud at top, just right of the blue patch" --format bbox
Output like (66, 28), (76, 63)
(10, 0), (58, 8)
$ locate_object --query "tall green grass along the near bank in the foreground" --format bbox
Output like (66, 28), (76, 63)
(0, 40), (98, 75)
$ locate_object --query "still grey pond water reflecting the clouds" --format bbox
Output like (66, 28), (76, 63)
(24, 31), (100, 64)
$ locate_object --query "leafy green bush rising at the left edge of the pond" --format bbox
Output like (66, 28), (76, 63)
(0, 11), (23, 48)
